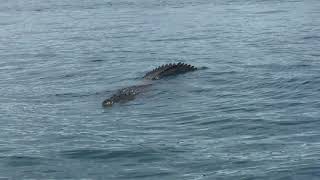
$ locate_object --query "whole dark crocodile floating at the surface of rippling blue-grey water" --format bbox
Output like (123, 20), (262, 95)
(102, 62), (199, 107)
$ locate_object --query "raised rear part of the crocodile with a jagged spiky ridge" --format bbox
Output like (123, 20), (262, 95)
(143, 62), (197, 80)
